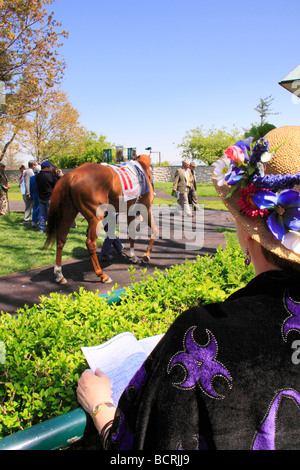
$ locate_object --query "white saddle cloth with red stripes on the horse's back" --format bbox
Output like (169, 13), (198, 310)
(101, 160), (149, 201)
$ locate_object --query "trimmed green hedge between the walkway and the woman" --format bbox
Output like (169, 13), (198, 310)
(0, 247), (253, 437)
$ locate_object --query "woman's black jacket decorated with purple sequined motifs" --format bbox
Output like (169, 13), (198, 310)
(109, 271), (300, 451)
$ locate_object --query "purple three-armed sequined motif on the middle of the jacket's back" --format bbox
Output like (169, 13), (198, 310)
(168, 326), (232, 398)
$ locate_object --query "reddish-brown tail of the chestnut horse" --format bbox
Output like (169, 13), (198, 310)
(44, 173), (74, 249)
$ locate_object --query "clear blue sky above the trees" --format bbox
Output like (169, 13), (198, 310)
(51, 0), (300, 162)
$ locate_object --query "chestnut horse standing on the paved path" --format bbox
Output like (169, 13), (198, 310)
(44, 155), (157, 284)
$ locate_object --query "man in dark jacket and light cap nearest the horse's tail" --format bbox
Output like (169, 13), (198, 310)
(36, 162), (62, 232)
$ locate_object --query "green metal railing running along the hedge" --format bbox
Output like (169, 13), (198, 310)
(0, 289), (131, 450)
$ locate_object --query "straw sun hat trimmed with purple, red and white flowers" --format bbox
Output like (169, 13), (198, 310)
(212, 126), (300, 264)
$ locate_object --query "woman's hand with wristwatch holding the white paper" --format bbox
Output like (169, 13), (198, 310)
(77, 369), (112, 417)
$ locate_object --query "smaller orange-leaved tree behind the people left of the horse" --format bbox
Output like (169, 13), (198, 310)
(23, 87), (86, 163)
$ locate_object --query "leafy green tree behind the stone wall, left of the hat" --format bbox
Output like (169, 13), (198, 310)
(178, 126), (240, 165)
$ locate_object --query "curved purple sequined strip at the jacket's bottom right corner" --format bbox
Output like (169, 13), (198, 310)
(253, 389), (300, 450)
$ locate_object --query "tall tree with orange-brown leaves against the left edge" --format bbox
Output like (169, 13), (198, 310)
(0, 0), (67, 161)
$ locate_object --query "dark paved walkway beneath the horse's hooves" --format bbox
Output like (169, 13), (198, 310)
(0, 190), (234, 313)
